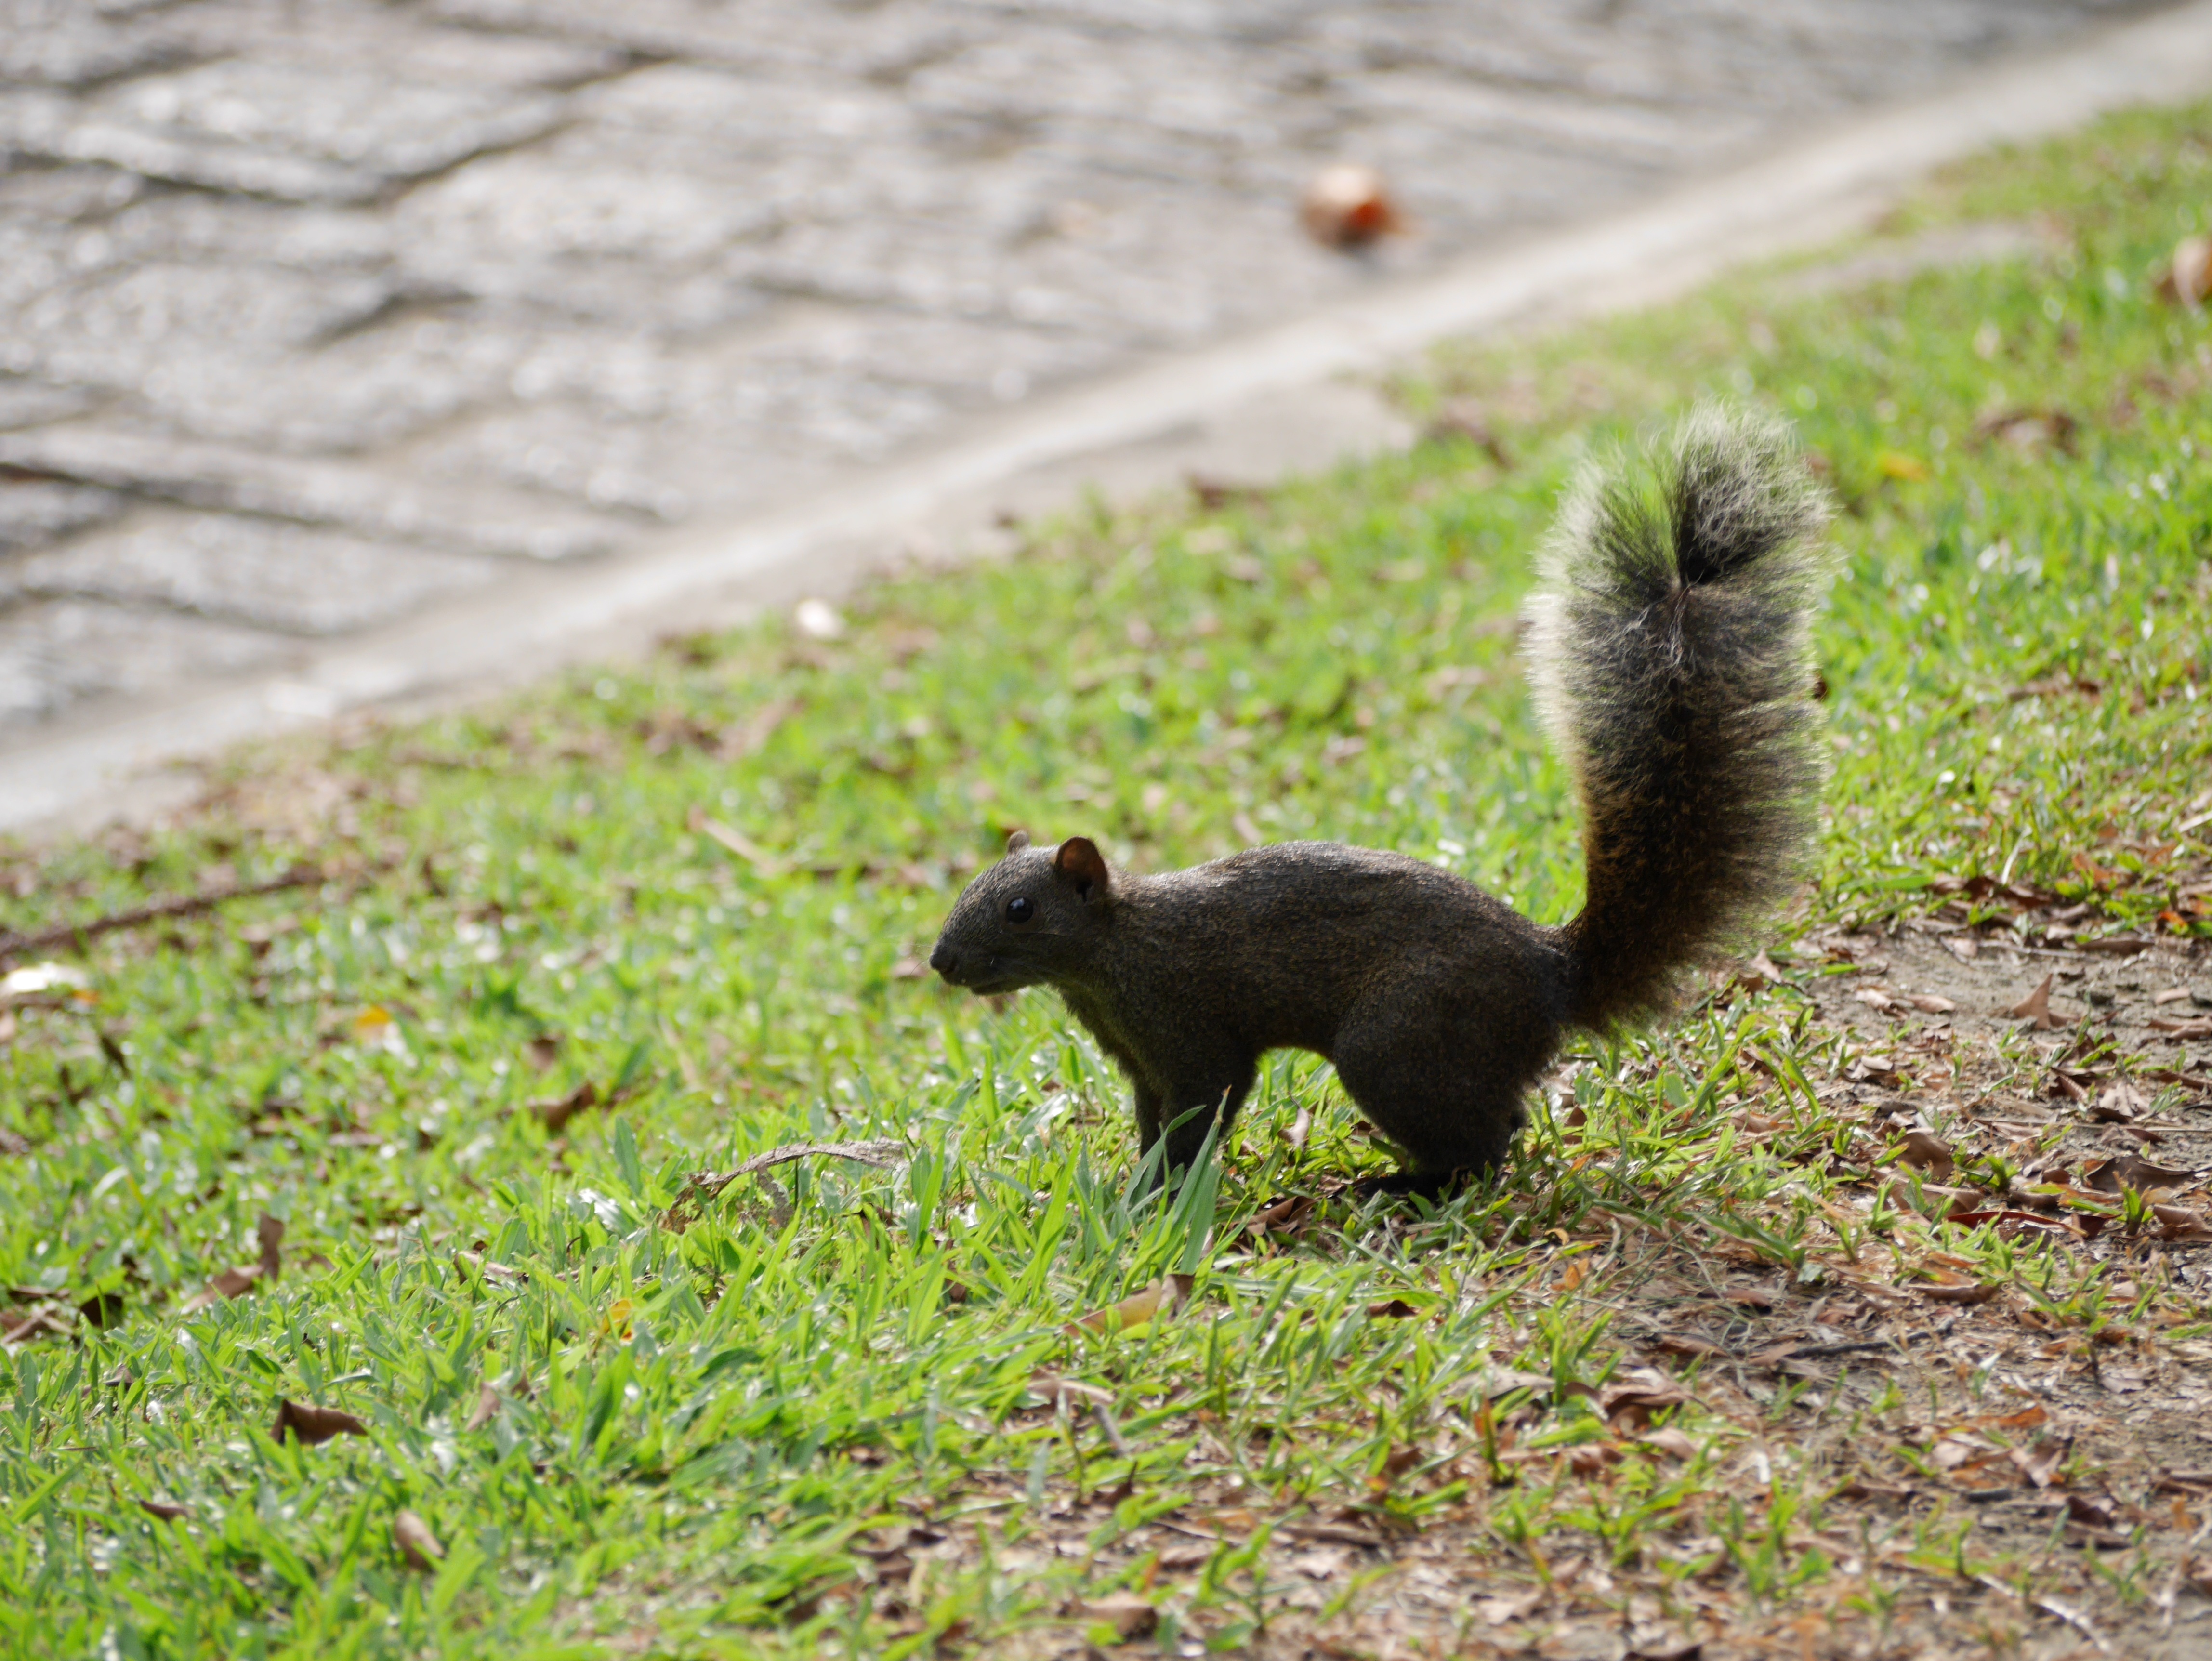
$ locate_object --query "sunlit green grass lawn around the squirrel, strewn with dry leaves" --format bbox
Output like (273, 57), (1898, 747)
(0, 100), (2212, 1657)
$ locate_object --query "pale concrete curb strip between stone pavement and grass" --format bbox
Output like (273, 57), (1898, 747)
(13, 0), (2212, 831)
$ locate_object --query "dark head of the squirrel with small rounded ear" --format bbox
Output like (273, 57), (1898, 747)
(929, 831), (1115, 993)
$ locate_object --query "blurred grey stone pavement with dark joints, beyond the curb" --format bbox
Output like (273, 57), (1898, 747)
(0, 0), (2155, 752)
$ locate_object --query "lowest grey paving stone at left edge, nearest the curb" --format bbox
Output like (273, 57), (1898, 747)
(0, 599), (299, 723)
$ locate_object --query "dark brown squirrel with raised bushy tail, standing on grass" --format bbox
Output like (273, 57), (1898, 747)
(929, 407), (1830, 1192)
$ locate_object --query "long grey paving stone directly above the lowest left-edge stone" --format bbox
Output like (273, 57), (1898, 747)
(17, 511), (500, 635)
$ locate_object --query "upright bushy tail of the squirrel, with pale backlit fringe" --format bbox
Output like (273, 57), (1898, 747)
(1531, 409), (1830, 1028)
